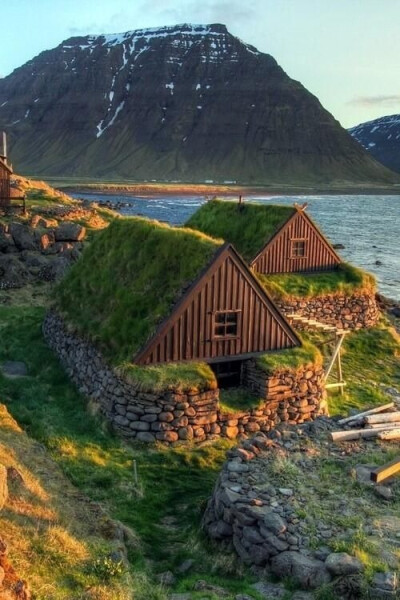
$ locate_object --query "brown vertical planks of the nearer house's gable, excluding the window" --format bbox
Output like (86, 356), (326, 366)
(139, 257), (294, 364)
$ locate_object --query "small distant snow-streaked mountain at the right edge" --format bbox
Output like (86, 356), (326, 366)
(349, 115), (400, 173)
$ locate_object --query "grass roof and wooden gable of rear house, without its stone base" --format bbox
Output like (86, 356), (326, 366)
(187, 200), (342, 274)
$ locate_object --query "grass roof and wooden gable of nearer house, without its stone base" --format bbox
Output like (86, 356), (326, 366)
(57, 218), (301, 365)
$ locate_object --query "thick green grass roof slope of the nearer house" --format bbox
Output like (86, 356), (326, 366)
(55, 217), (222, 365)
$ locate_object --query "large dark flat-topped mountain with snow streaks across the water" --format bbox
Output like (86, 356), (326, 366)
(0, 24), (395, 183)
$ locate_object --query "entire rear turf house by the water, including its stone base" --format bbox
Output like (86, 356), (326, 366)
(186, 199), (379, 329)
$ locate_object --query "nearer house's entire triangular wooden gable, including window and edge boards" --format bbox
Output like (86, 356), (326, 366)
(134, 244), (301, 365)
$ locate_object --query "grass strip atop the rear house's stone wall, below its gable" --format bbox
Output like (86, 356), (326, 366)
(257, 263), (376, 299)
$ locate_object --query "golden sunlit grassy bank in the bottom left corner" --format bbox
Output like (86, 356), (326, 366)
(0, 406), (131, 600)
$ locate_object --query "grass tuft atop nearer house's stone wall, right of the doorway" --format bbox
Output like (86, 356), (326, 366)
(256, 335), (322, 373)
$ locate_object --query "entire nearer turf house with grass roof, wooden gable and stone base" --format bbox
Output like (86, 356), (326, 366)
(43, 217), (323, 442)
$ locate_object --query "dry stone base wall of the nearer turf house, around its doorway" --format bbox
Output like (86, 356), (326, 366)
(43, 312), (325, 443)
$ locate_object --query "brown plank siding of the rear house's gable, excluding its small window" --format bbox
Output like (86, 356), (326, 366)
(251, 211), (340, 274)
